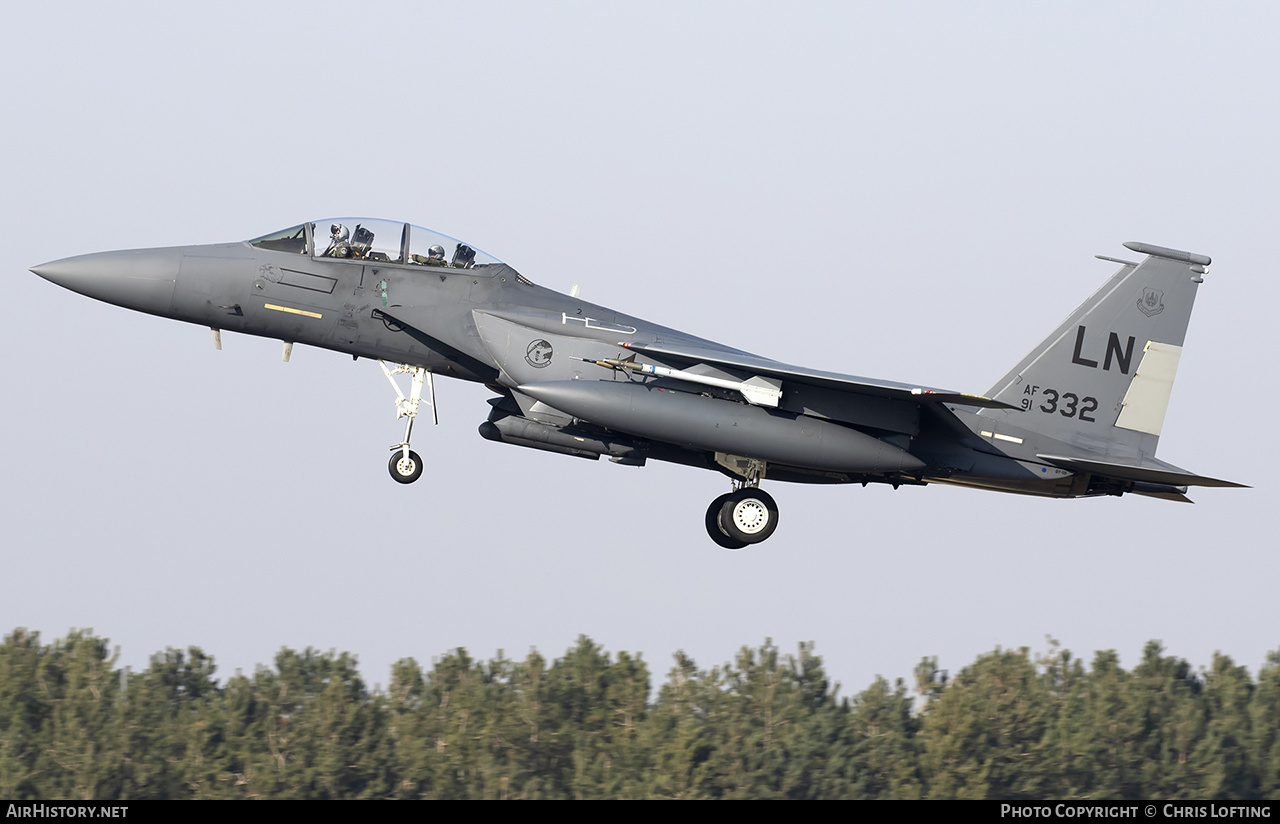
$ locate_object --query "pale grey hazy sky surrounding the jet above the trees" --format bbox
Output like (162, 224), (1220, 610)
(0, 1), (1280, 695)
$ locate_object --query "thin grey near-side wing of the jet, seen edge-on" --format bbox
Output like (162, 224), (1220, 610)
(622, 343), (1019, 409)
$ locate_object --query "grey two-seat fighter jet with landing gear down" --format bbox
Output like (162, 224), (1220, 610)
(32, 218), (1240, 549)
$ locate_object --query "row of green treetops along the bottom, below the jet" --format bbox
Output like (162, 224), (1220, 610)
(0, 630), (1280, 800)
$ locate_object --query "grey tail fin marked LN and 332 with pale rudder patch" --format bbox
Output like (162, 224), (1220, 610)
(982, 243), (1210, 458)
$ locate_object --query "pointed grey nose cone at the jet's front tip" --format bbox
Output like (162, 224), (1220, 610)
(31, 248), (182, 315)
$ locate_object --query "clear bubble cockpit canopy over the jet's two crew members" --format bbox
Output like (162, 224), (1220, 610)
(250, 218), (502, 269)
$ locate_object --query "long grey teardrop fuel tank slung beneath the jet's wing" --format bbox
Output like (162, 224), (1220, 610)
(520, 380), (924, 472)
